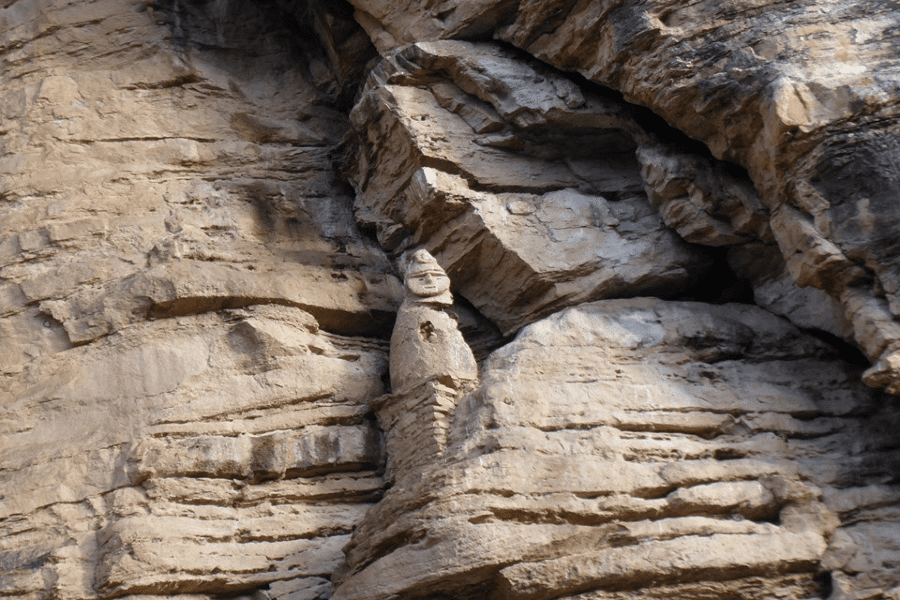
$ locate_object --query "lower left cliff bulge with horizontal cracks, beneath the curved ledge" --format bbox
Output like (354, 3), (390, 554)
(0, 307), (386, 598)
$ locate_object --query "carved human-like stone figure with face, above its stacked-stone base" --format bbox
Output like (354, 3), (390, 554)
(390, 250), (478, 393)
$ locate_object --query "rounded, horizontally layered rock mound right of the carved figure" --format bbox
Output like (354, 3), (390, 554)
(334, 299), (900, 600)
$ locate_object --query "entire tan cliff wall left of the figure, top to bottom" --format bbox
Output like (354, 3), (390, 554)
(0, 0), (392, 600)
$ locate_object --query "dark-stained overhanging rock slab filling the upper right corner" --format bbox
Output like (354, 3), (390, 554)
(344, 0), (900, 391)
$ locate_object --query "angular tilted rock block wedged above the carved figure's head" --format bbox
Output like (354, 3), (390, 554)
(344, 41), (711, 334)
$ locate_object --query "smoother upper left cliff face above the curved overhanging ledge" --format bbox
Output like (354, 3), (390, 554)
(0, 1), (400, 369)
